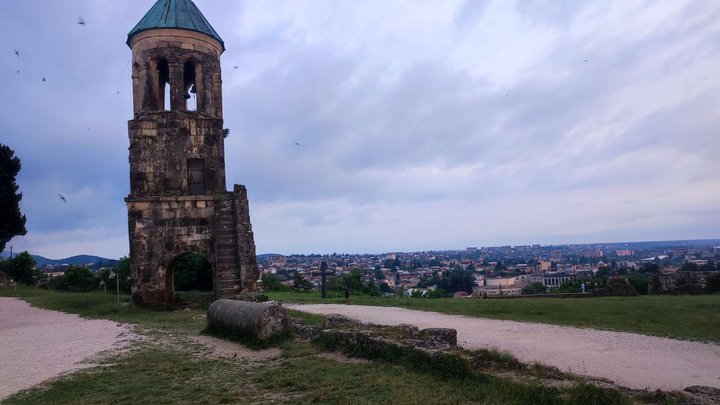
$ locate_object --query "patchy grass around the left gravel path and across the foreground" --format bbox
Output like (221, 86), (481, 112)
(0, 288), (648, 404)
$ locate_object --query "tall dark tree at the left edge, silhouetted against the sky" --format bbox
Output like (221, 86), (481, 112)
(0, 144), (27, 252)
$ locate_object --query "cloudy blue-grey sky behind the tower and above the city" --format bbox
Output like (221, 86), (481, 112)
(0, 0), (720, 258)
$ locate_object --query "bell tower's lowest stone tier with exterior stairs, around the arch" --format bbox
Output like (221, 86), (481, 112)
(126, 191), (259, 306)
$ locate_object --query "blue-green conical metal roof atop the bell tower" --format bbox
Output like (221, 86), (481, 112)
(127, 0), (225, 50)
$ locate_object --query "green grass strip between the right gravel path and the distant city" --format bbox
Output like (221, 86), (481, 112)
(268, 292), (720, 342)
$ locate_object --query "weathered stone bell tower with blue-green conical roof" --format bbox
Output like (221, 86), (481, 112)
(125, 0), (258, 306)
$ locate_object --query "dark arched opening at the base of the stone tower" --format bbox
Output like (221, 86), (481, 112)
(168, 253), (214, 307)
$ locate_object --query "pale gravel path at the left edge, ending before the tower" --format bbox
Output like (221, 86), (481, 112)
(0, 298), (131, 401)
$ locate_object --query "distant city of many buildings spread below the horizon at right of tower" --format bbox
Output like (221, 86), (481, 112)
(259, 240), (720, 297)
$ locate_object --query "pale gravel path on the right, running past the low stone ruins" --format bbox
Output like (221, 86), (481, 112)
(288, 304), (720, 389)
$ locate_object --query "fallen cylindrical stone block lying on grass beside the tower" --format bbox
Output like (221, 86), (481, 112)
(207, 299), (290, 340)
